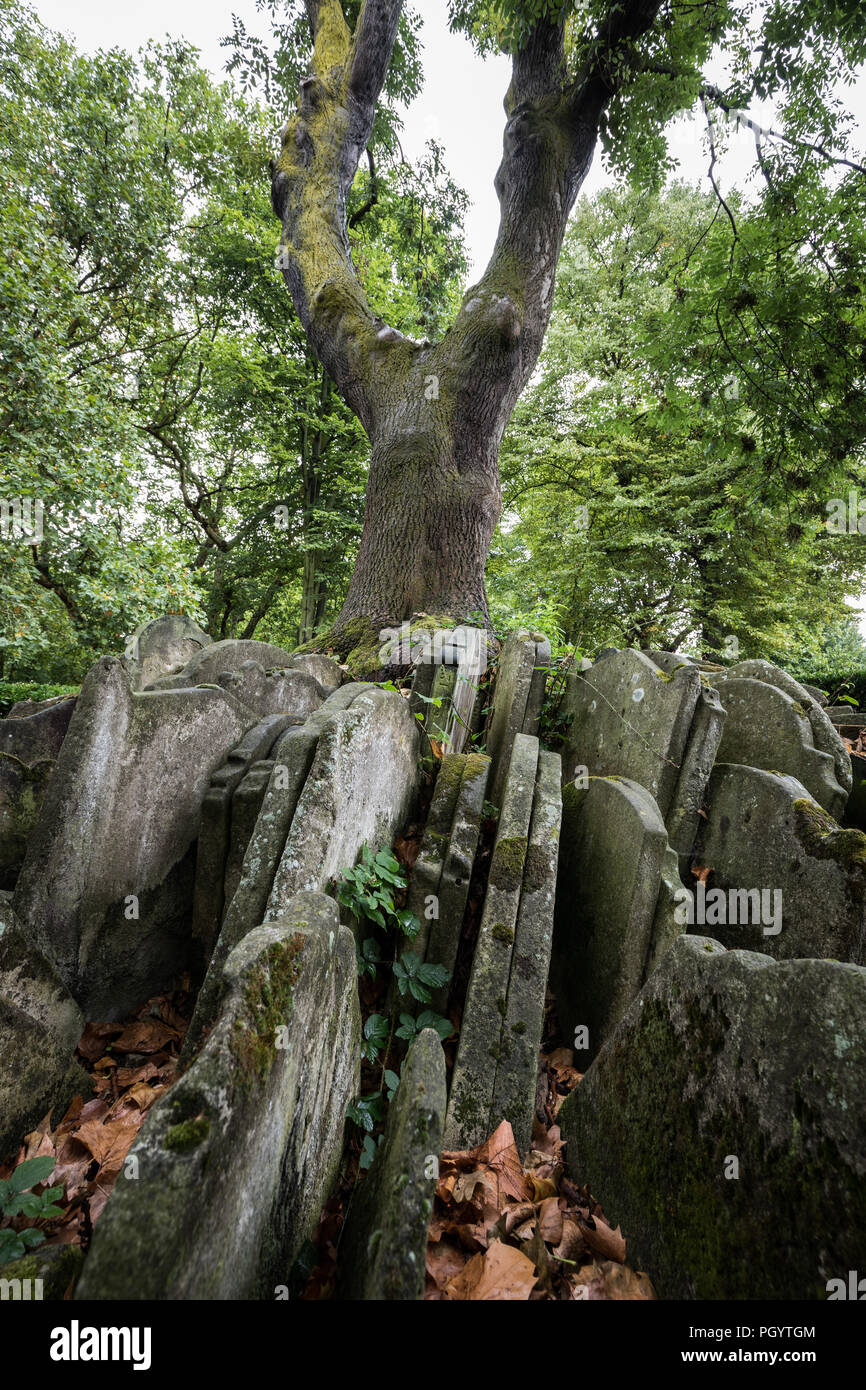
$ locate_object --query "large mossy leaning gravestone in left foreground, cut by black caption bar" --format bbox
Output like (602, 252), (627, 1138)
(76, 894), (360, 1300)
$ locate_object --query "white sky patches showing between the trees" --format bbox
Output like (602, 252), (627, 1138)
(35, 0), (866, 274)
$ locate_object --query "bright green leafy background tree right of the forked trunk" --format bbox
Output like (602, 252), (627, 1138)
(489, 185), (866, 666)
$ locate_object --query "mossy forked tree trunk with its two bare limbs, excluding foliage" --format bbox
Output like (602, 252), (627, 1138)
(272, 0), (660, 630)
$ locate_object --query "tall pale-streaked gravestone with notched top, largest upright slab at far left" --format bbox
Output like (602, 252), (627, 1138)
(14, 657), (254, 1019)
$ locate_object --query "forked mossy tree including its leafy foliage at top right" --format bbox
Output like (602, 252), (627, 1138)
(272, 0), (866, 634)
